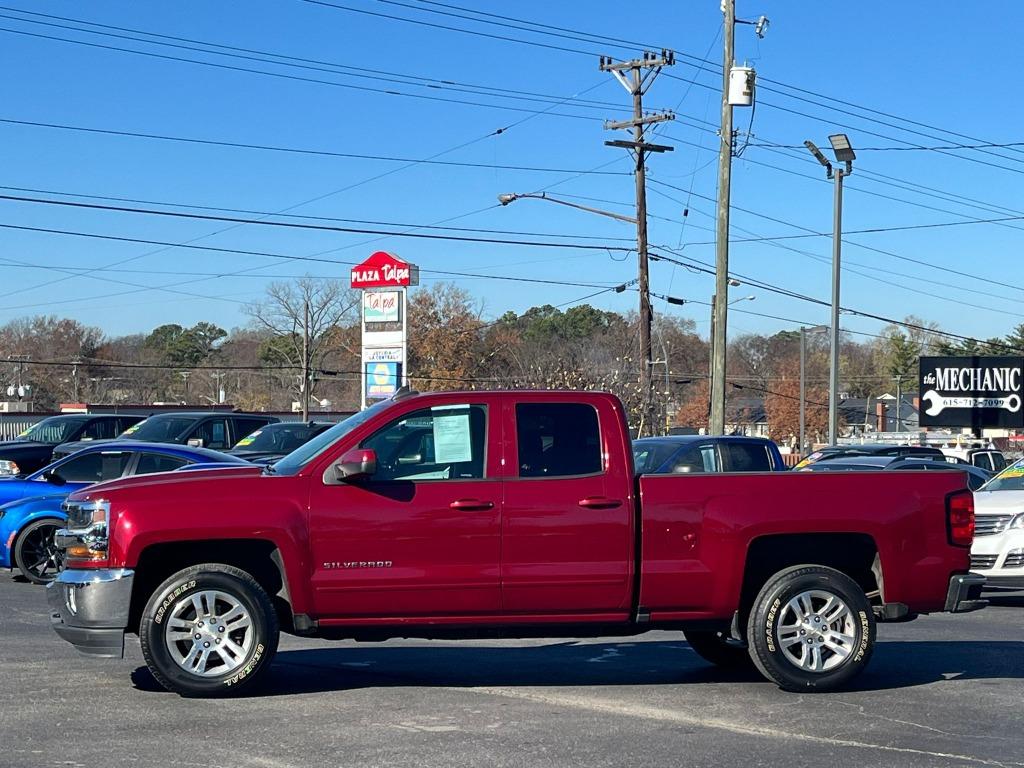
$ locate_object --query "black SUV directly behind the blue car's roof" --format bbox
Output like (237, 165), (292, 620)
(53, 411), (281, 459)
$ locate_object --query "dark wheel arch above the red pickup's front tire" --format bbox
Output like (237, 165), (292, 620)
(128, 539), (294, 633)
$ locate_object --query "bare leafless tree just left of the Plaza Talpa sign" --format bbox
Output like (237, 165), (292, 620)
(246, 276), (359, 419)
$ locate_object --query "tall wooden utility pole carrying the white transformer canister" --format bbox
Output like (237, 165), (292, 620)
(708, 0), (736, 434)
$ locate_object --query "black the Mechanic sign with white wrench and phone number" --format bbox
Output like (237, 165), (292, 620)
(920, 357), (1024, 429)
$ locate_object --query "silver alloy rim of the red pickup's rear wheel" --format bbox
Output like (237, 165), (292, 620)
(775, 590), (857, 672)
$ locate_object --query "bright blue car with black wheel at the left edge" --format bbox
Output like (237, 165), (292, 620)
(0, 440), (248, 584)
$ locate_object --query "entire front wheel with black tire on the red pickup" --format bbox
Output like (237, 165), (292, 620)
(138, 563), (280, 697)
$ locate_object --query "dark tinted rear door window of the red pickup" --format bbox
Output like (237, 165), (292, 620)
(515, 402), (603, 477)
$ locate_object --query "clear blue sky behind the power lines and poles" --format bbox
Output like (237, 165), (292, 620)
(0, 0), (1024, 337)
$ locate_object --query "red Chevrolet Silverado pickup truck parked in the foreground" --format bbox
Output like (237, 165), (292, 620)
(48, 392), (985, 696)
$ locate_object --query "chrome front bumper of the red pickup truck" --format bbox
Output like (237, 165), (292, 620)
(46, 568), (135, 658)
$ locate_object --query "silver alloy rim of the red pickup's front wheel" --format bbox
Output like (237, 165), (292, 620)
(164, 590), (255, 677)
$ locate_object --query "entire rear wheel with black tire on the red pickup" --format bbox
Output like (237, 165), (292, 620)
(746, 565), (874, 693)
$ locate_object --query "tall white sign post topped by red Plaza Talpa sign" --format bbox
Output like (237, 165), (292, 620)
(351, 251), (420, 408)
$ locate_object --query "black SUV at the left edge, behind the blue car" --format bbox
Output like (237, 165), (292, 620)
(0, 414), (142, 476)
